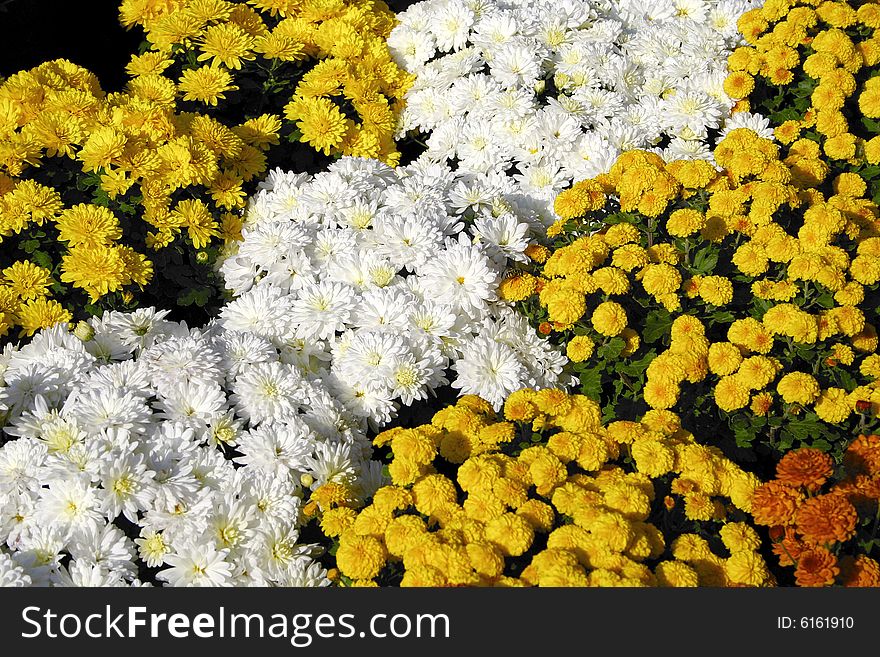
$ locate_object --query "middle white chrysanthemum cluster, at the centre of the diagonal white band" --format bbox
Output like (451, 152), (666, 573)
(220, 158), (567, 418)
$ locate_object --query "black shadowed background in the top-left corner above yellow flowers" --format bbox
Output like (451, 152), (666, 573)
(0, 0), (413, 91)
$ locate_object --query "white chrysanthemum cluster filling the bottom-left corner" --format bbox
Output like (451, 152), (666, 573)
(0, 316), (376, 586)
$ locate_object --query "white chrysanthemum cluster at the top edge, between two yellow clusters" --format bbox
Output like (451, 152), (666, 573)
(389, 0), (773, 223)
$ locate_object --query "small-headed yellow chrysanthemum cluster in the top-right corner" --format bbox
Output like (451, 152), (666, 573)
(724, 0), (880, 164)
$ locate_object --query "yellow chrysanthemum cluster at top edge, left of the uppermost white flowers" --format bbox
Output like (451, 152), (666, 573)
(120, 0), (411, 165)
